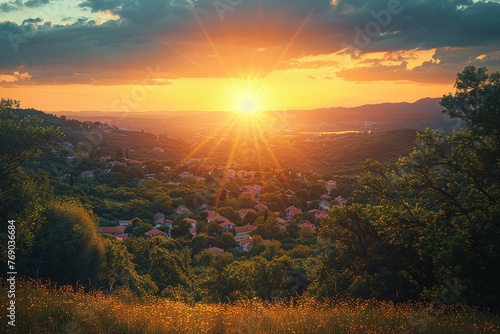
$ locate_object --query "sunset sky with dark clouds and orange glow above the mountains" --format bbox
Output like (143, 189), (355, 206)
(0, 0), (500, 112)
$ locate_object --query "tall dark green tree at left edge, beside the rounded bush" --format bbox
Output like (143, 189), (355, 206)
(0, 99), (62, 275)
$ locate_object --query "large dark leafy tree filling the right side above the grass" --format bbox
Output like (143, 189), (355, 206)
(321, 66), (500, 309)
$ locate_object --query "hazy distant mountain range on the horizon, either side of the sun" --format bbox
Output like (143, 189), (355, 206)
(49, 98), (443, 133)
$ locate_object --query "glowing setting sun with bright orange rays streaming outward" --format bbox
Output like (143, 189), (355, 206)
(178, 10), (311, 201)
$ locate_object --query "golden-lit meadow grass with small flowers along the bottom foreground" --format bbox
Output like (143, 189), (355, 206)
(0, 281), (500, 334)
